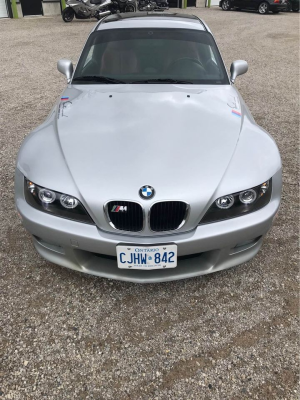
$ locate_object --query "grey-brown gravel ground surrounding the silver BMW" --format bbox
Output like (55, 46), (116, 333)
(0, 8), (299, 400)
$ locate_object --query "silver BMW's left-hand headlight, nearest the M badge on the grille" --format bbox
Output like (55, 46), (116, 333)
(24, 178), (94, 224)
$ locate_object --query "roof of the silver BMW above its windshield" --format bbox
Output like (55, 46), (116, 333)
(94, 12), (210, 32)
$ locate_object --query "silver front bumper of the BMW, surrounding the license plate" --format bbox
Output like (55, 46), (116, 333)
(15, 170), (281, 283)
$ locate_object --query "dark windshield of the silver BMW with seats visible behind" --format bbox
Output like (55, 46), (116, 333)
(73, 28), (229, 85)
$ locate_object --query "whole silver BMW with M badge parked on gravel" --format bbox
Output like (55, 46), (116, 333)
(15, 13), (281, 282)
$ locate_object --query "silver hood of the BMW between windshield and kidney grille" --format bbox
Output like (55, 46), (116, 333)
(57, 85), (243, 228)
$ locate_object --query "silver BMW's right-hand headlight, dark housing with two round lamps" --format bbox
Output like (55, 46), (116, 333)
(200, 179), (272, 225)
